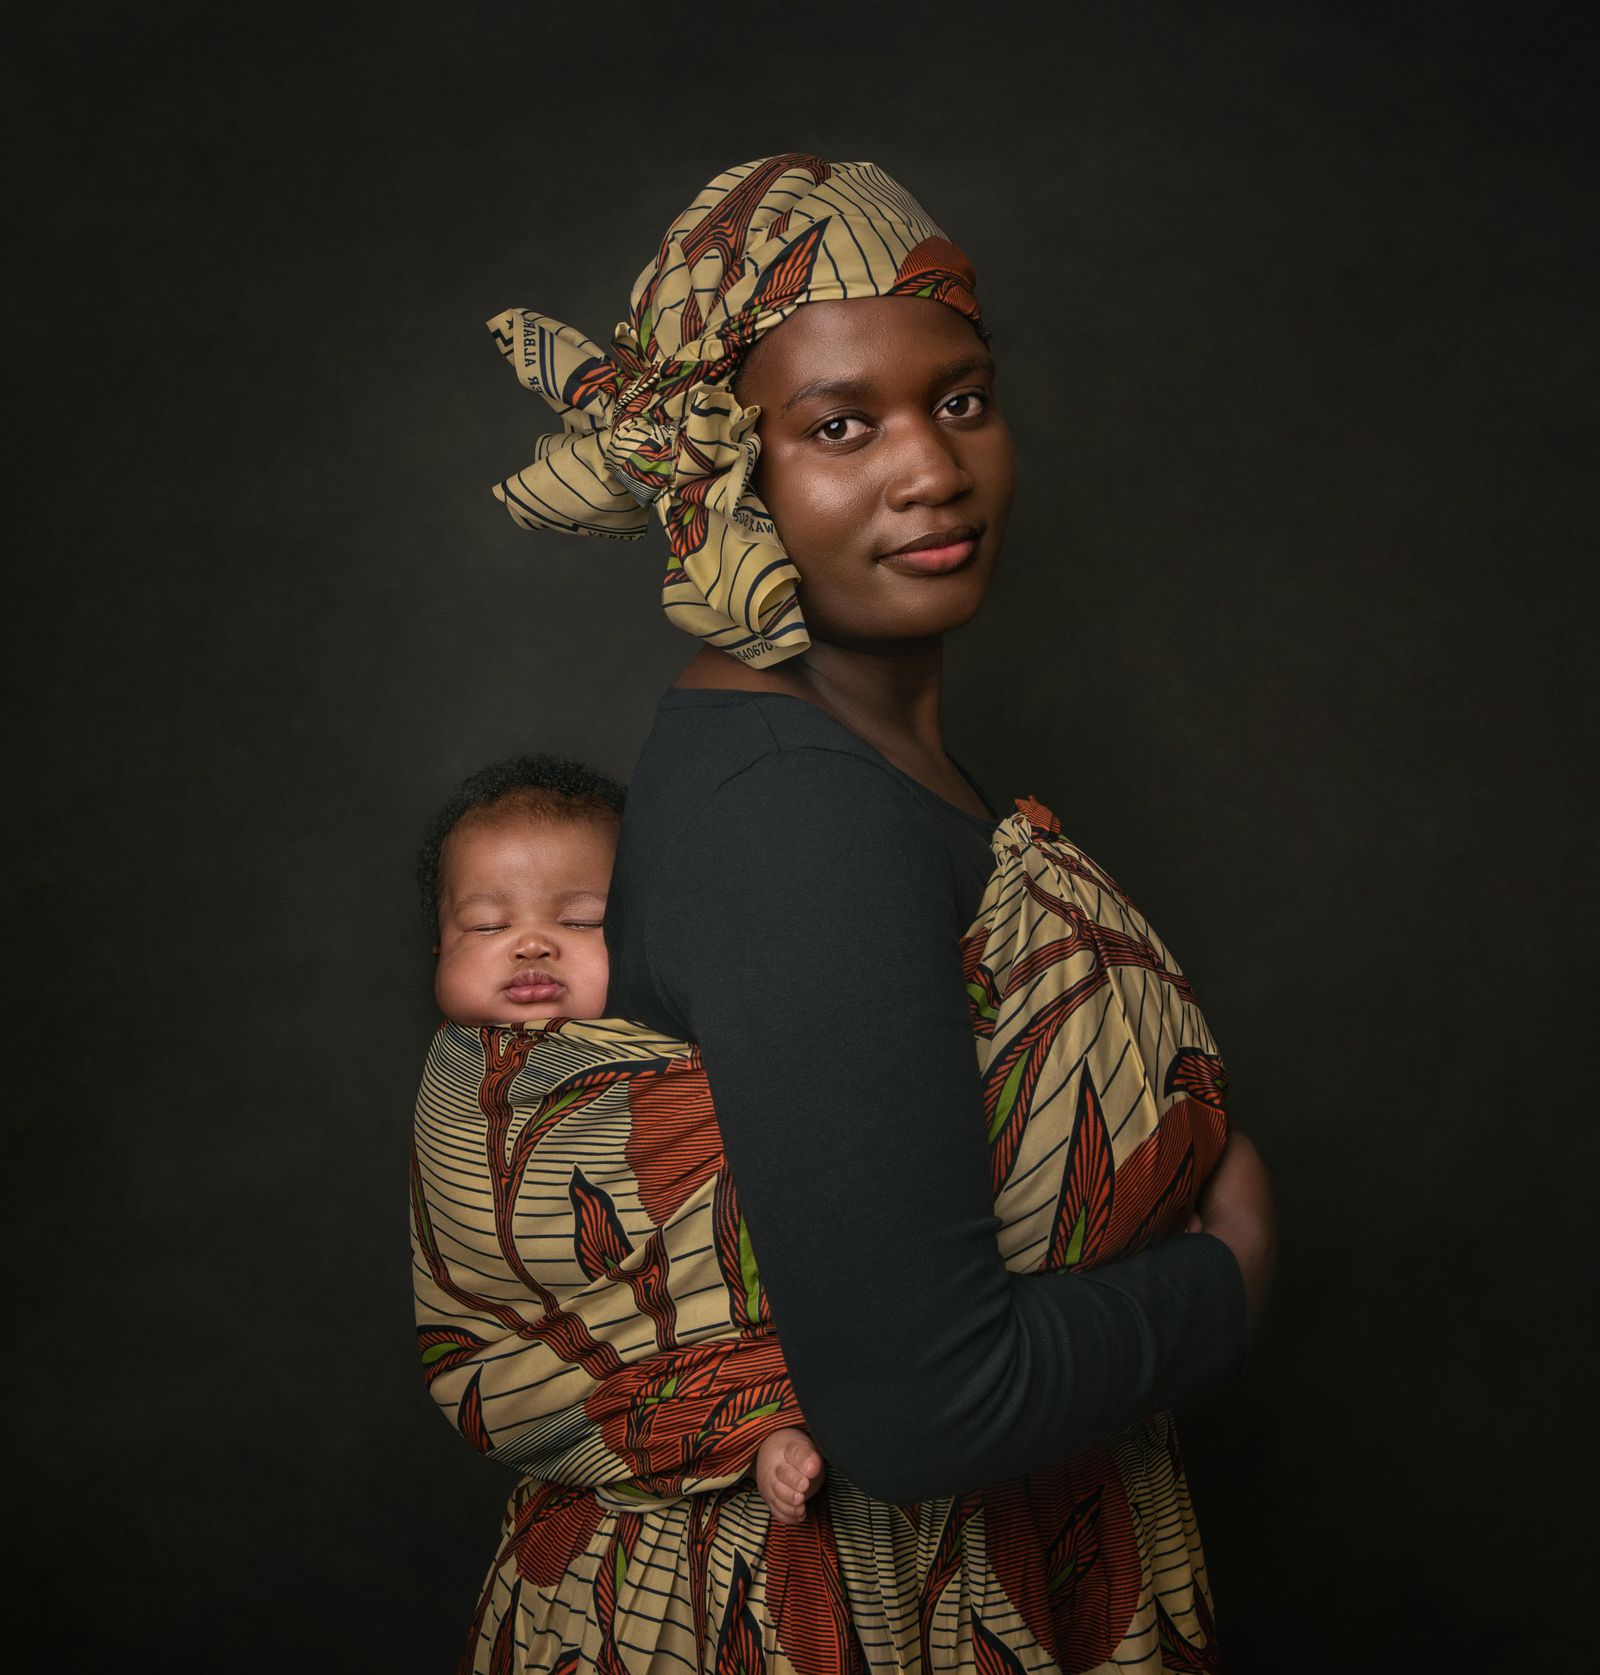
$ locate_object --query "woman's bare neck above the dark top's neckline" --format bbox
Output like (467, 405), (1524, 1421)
(677, 638), (988, 814)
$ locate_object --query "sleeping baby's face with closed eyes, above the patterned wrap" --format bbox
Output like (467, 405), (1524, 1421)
(434, 809), (617, 1027)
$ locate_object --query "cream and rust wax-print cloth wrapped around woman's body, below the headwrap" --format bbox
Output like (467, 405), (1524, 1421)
(412, 802), (1226, 1675)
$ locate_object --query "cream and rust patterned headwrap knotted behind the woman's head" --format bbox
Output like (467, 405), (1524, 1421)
(489, 152), (983, 665)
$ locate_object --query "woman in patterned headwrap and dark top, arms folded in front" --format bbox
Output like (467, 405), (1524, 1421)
(419, 156), (1272, 1675)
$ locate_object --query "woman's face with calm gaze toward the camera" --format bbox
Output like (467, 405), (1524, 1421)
(739, 296), (1014, 645)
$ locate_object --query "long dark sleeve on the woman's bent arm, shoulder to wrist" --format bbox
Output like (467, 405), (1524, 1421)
(647, 749), (1245, 1502)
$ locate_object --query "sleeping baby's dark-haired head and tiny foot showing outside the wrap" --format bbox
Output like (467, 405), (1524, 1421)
(417, 755), (823, 1524)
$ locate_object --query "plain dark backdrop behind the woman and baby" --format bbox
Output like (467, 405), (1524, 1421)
(5, 0), (1597, 1675)
